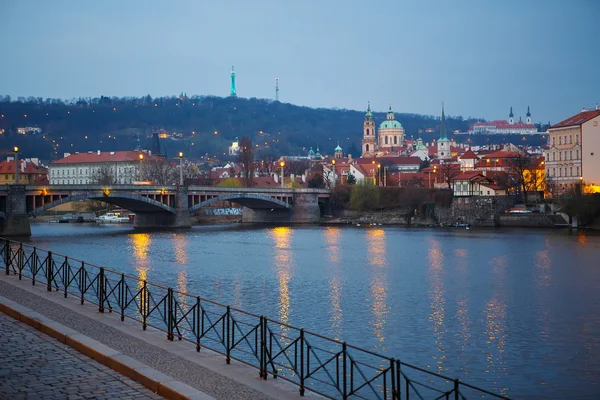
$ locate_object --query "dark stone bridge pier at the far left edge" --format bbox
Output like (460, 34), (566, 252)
(0, 185), (31, 236)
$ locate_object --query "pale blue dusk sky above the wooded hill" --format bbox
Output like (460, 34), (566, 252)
(0, 0), (600, 123)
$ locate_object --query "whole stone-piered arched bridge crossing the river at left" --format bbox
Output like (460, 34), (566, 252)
(0, 185), (330, 236)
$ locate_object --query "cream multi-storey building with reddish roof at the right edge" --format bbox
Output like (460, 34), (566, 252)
(545, 106), (600, 193)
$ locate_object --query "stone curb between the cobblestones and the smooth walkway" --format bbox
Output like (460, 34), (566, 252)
(0, 296), (215, 400)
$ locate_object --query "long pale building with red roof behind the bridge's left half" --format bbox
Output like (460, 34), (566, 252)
(49, 150), (148, 185)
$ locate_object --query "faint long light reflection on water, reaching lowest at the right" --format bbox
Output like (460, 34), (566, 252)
(484, 256), (508, 395)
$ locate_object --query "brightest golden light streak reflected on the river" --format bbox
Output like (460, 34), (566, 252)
(269, 226), (293, 324)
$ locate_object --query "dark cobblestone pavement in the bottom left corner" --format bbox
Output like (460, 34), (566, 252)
(0, 312), (162, 400)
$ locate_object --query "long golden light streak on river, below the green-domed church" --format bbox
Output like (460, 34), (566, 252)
(367, 229), (389, 352)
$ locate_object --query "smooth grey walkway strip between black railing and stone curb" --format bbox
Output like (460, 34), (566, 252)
(0, 273), (302, 400)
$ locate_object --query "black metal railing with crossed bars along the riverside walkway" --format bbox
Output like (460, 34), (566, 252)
(0, 239), (507, 400)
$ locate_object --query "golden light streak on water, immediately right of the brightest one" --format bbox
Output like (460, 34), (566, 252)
(323, 226), (343, 339)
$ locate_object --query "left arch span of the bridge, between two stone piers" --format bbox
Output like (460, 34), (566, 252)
(28, 191), (176, 217)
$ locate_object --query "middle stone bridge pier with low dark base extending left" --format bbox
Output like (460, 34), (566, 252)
(133, 186), (192, 229)
